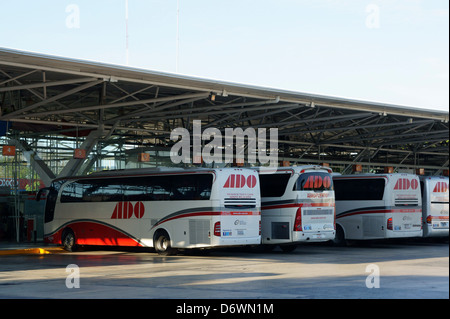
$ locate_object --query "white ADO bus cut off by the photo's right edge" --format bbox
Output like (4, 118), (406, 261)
(420, 176), (449, 237)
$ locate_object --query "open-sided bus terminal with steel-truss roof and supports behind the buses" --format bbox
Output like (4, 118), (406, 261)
(0, 48), (449, 241)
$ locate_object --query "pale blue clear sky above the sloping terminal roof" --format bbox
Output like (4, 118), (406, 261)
(0, 0), (449, 111)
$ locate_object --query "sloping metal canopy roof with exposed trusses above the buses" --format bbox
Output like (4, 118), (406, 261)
(0, 48), (449, 174)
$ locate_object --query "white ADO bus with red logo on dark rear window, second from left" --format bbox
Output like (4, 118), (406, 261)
(258, 165), (335, 251)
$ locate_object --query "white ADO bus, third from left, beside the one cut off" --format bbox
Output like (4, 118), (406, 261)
(333, 174), (422, 244)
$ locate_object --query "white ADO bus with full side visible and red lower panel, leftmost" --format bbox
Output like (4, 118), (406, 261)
(38, 168), (261, 254)
